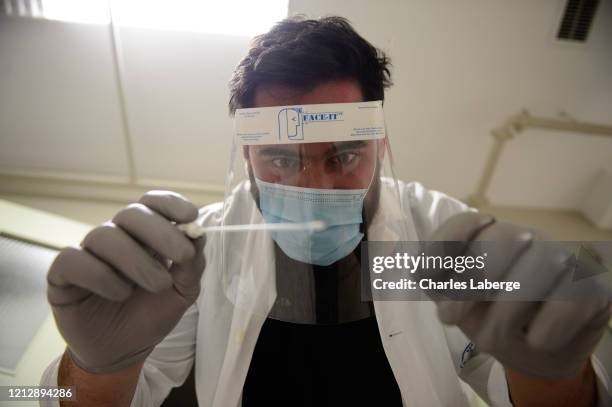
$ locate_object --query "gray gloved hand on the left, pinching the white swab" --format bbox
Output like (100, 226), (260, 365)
(47, 191), (205, 373)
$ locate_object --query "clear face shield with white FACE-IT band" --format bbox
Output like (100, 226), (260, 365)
(220, 102), (406, 324)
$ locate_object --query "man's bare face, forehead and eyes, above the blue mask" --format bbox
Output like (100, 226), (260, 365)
(245, 80), (379, 193)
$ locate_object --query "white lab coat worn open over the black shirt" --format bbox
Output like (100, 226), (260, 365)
(42, 182), (612, 407)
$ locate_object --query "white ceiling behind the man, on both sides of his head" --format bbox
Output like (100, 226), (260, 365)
(0, 0), (612, 208)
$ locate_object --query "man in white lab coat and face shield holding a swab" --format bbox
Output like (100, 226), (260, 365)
(43, 17), (610, 406)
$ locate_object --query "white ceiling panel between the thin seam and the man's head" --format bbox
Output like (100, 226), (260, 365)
(115, 28), (250, 185)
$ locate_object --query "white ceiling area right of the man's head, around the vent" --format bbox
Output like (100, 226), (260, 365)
(290, 0), (612, 208)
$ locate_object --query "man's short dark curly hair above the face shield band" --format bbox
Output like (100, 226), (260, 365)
(229, 16), (392, 114)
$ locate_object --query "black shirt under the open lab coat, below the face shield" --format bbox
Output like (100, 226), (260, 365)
(242, 316), (402, 407)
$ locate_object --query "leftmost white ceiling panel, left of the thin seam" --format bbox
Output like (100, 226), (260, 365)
(0, 17), (127, 175)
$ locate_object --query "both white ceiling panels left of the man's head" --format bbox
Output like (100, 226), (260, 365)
(0, 17), (250, 185)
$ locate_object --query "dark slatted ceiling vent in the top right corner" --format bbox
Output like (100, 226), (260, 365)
(557, 0), (599, 42)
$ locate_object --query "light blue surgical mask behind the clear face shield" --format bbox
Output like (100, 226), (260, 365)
(255, 178), (367, 266)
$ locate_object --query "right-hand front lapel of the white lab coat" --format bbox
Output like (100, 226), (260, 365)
(368, 183), (468, 407)
